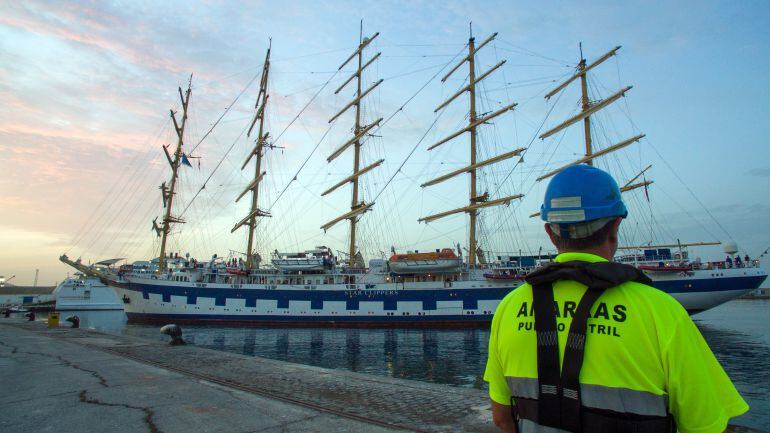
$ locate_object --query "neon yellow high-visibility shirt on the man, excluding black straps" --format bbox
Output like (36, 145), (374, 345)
(484, 253), (749, 433)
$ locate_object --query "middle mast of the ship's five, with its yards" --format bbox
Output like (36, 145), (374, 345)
(321, 23), (384, 267)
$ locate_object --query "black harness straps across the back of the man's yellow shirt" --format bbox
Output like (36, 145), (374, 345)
(525, 261), (652, 432)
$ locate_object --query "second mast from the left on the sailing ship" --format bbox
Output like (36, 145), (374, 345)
(230, 40), (272, 269)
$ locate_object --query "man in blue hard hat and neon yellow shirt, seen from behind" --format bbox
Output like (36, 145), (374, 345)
(484, 165), (748, 433)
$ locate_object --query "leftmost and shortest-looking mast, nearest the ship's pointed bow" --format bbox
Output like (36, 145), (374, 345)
(153, 75), (192, 272)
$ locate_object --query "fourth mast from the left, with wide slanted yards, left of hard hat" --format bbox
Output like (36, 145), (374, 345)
(419, 33), (524, 266)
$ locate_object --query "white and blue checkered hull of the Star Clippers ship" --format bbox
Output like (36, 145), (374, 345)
(106, 268), (766, 326)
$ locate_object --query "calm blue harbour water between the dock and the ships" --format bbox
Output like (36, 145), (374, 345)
(62, 300), (770, 429)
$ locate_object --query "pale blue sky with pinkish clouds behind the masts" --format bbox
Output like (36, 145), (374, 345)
(0, 1), (770, 284)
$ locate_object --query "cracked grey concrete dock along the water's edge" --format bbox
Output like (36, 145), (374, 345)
(0, 318), (754, 433)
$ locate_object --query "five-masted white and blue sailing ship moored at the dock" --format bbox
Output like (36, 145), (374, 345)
(61, 33), (766, 326)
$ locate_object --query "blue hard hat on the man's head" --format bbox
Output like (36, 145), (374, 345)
(540, 164), (628, 224)
